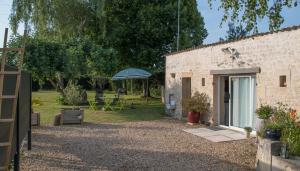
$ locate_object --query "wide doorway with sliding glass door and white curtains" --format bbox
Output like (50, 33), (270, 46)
(218, 75), (256, 129)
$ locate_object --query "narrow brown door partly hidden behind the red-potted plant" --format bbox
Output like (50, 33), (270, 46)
(181, 77), (192, 117)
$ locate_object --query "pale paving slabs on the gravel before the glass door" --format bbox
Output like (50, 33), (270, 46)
(183, 127), (246, 142)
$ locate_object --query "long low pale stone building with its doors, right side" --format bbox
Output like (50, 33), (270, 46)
(165, 26), (300, 129)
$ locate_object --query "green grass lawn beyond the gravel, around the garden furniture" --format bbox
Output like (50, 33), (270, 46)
(32, 91), (164, 125)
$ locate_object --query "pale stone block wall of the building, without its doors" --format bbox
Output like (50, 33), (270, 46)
(165, 28), (300, 121)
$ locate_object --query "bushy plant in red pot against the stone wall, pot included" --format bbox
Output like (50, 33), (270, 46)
(183, 91), (210, 124)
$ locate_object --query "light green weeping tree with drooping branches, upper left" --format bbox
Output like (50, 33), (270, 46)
(10, 0), (105, 40)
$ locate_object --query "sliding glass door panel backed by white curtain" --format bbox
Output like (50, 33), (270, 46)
(229, 76), (255, 128)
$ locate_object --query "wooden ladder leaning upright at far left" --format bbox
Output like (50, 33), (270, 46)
(0, 28), (26, 171)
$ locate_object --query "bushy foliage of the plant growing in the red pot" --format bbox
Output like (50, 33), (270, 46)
(183, 91), (210, 114)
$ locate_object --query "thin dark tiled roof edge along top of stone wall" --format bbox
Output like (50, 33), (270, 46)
(165, 25), (300, 57)
